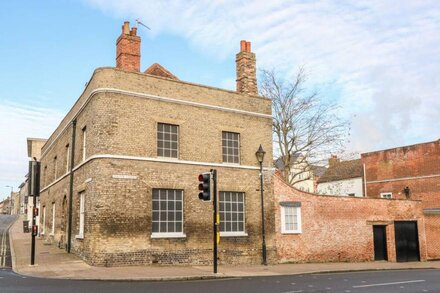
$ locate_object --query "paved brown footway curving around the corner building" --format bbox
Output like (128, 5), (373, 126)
(9, 218), (440, 281)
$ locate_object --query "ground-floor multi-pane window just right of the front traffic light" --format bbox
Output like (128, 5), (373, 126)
(220, 191), (247, 236)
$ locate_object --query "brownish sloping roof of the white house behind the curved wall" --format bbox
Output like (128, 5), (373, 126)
(318, 159), (363, 183)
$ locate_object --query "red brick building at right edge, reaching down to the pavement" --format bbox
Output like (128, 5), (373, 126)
(361, 140), (440, 259)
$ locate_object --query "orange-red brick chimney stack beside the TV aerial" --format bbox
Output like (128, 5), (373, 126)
(116, 21), (141, 72)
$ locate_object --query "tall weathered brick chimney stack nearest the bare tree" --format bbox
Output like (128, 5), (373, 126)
(235, 40), (258, 95)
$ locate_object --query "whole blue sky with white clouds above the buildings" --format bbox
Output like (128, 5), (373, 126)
(0, 0), (440, 199)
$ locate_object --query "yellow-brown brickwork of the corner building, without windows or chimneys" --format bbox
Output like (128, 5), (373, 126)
(40, 68), (275, 266)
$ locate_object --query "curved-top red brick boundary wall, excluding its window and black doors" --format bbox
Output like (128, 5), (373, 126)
(274, 176), (426, 262)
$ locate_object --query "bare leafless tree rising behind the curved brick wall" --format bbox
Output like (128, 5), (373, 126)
(260, 67), (349, 185)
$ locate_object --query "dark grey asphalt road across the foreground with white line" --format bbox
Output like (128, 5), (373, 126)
(0, 269), (440, 293)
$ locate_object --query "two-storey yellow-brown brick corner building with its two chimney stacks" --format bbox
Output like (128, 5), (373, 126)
(40, 22), (276, 266)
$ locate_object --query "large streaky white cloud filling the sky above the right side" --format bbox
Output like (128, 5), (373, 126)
(87, 0), (440, 151)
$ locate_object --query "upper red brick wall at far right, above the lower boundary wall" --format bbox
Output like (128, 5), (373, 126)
(362, 140), (440, 208)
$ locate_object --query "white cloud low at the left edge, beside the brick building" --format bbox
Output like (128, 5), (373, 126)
(0, 101), (64, 190)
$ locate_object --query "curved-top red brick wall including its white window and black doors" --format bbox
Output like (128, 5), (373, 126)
(274, 175), (427, 263)
